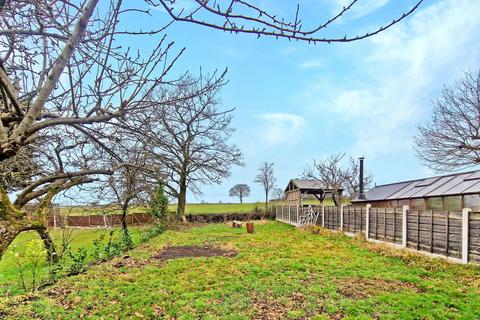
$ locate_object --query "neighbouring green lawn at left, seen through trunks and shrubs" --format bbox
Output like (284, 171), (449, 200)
(0, 227), (144, 296)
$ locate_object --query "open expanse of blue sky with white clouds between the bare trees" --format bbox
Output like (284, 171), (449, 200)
(138, 0), (480, 202)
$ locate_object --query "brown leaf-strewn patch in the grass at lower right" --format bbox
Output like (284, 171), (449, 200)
(336, 278), (420, 299)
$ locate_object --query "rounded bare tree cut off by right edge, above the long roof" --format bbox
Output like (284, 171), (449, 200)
(414, 70), (480, 171)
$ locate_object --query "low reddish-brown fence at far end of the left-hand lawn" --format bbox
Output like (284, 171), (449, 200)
(47, 213), (153, 228)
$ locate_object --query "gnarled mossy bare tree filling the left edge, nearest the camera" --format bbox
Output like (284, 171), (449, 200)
(0, 0), (181, 258)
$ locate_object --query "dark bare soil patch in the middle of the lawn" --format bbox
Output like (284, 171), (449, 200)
(153, 246), (237, 261)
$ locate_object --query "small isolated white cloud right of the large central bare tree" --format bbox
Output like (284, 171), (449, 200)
(257, 113), (306, 147)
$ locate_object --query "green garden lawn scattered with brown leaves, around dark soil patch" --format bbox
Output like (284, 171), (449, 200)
(0, 222), (480, 319)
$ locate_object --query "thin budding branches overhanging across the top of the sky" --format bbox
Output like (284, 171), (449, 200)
(152, 0), (423, 43)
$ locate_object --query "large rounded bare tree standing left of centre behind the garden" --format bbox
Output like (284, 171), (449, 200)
(134, 73), (243, 222)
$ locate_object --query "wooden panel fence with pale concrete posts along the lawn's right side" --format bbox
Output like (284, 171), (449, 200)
(275, 205), (480, 263)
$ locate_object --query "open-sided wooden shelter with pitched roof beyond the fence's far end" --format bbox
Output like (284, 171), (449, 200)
(284, 179), (343, 206)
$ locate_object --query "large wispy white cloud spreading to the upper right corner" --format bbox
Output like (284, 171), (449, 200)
(299, 0), (480, 156)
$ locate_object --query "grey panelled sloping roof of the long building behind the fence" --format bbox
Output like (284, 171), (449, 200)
(352, 170), (480, 202)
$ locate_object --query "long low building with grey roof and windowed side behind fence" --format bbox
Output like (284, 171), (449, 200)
(352, 171), (480, 210)
